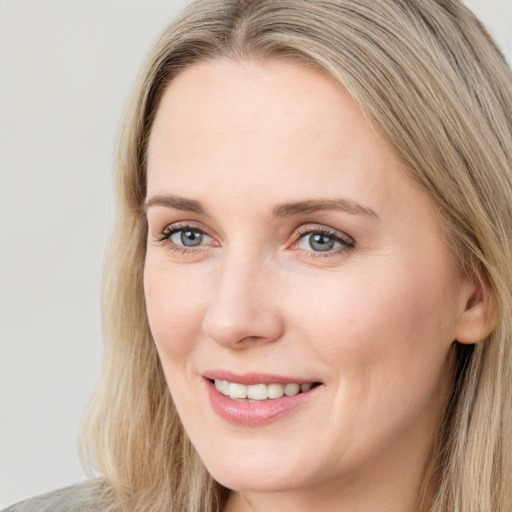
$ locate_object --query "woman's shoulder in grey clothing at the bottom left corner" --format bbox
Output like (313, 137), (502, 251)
(2, 480), (102, 512)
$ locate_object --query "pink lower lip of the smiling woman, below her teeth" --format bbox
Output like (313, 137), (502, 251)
(205, 380), (323, 427)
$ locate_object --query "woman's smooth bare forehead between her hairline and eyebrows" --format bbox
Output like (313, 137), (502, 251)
(148, 59), (424, 220)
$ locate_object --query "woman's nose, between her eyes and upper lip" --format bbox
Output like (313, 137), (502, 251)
(202, 252), (284, 350)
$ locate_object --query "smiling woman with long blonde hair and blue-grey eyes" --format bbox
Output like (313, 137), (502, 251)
(5, 0), (512, 512)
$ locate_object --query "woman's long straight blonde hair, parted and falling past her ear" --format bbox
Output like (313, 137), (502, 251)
(83, 0), (512, 512)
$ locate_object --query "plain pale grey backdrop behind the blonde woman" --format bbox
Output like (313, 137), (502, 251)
(0, 0), (512, 507)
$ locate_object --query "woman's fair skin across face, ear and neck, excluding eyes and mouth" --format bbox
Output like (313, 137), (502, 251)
(144, 59), (484, 512)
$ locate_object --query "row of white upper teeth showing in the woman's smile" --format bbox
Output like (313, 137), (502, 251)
(210, 379), (313, 400)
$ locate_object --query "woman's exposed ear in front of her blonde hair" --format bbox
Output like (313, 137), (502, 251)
(455, 277), (496, 344)
